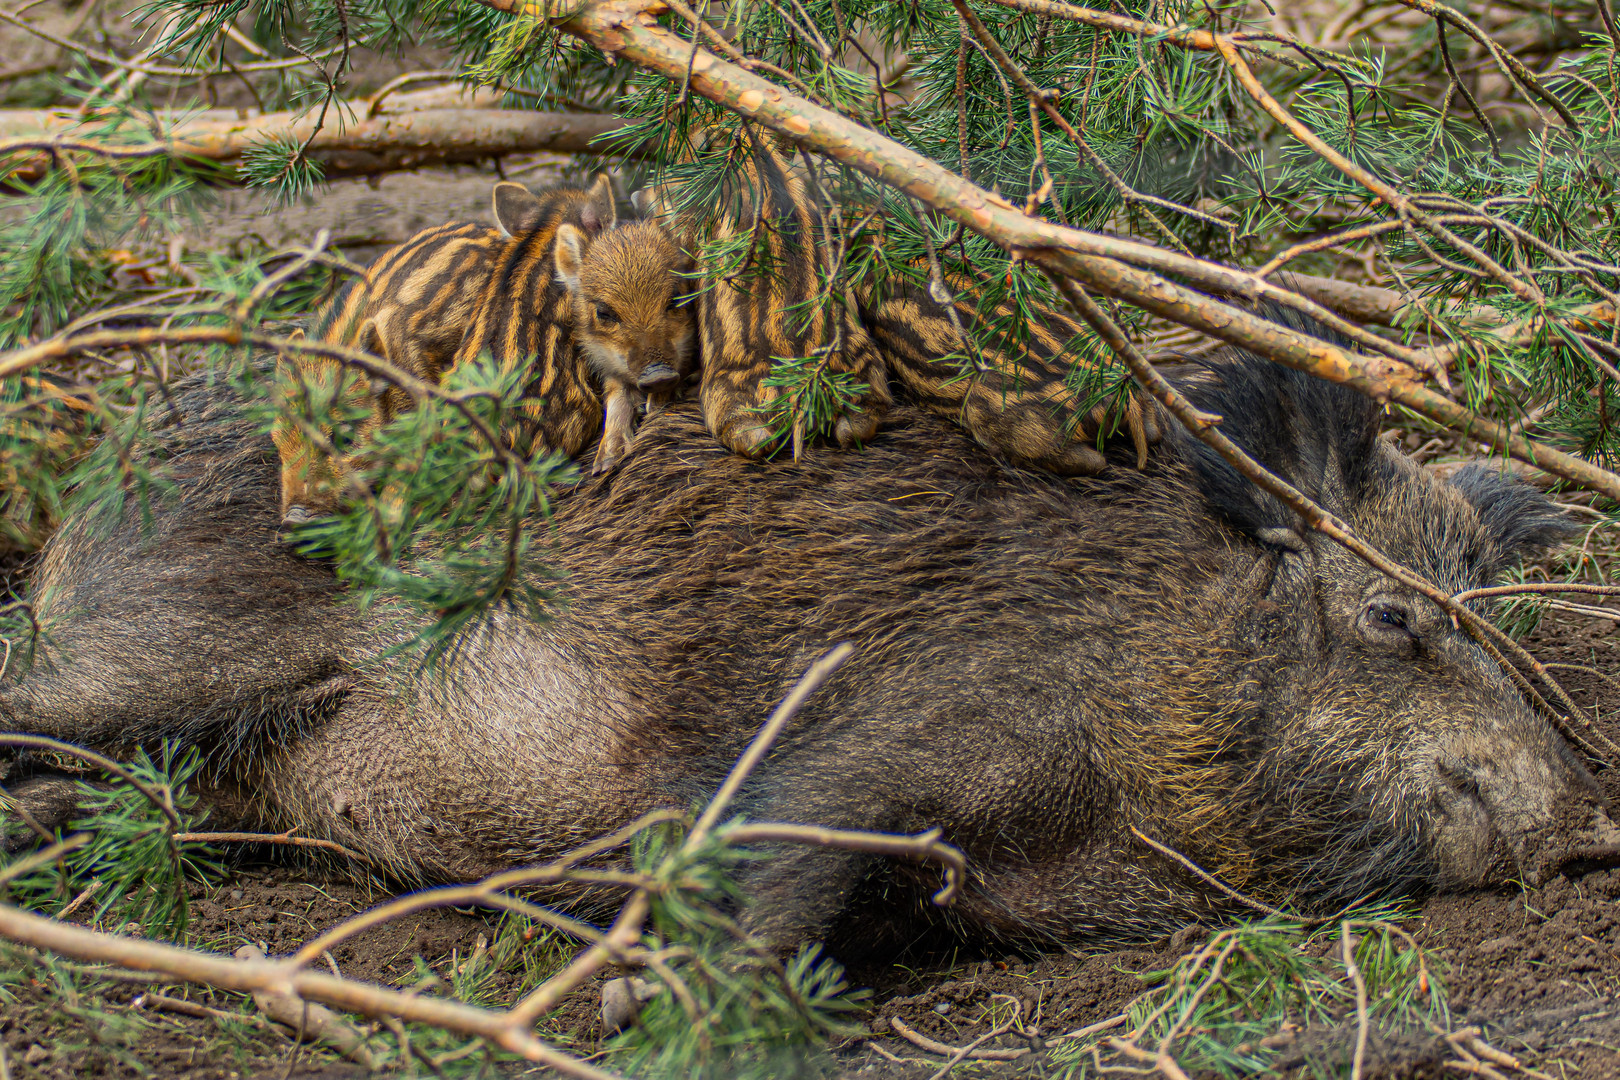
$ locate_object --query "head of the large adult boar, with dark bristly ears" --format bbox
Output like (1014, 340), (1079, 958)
(1176, 335), (1612, 904)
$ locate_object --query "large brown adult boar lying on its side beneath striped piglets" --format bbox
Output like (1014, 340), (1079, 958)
(0, 341), (1601, 944)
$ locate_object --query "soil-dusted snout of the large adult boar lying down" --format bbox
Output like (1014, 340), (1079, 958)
(1432, 724), (1614, 886)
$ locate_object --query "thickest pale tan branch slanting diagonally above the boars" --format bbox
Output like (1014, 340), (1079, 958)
(492, 0), (1620, 500)
